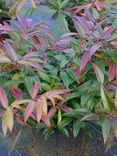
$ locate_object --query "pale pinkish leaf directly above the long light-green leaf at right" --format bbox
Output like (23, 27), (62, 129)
(93, 63), (104, 84)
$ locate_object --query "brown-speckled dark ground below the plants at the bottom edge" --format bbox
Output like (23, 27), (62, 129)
(16, 129), (117, 156)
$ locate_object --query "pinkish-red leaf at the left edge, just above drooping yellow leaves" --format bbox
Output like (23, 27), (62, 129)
(0, 87), (8, 108)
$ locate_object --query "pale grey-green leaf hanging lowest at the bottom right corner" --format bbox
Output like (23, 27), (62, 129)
(102, 119), (111, 143)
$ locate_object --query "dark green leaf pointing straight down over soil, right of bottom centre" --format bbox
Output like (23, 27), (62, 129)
(73, 120), (82, 138)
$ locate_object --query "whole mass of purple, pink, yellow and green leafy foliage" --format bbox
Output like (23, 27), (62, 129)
(0, 0), (117, 154)
